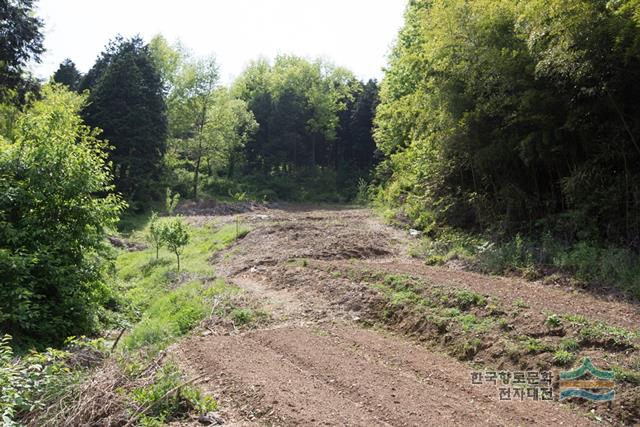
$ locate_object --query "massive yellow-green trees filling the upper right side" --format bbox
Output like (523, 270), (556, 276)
(375, 0), (640, 242)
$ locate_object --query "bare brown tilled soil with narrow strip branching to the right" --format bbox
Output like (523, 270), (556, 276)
(173, 208), (640, 426)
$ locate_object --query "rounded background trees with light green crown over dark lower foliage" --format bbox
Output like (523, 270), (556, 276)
(233, 55), (357, 173)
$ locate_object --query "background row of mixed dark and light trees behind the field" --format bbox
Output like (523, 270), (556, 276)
(53, 36), (378, 207)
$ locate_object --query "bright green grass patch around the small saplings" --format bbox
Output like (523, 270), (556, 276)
(116, 222), (248, 351)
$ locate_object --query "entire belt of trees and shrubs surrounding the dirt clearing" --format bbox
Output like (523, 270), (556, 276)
(0, 0), (640, 419)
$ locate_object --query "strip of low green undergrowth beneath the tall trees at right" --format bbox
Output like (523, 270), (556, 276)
(411, 230), (640, 299)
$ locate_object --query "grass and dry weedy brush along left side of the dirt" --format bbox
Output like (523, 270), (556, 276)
(0, 216), (255, 426)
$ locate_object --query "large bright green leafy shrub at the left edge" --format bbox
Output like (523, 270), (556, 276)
(0, 86), (124, 345)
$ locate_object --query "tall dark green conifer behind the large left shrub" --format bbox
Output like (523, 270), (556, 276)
(81, 37), (167, 201)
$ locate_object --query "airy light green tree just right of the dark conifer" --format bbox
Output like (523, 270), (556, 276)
(150, 36), (257, 200)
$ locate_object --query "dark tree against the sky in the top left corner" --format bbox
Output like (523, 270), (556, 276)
(0, 0), (44, 102)
